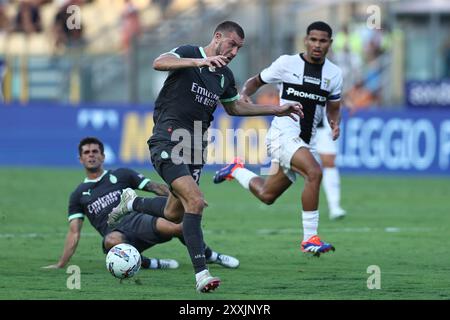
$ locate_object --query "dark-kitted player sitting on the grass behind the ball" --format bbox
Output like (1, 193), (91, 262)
(44, 137), (239, 269)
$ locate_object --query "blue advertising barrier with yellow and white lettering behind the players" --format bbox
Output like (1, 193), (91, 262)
(0, 104), (450, 176)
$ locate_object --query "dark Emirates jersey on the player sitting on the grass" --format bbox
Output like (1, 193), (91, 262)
(69, 168), (150, 236)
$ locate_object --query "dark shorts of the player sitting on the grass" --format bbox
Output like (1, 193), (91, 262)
(103, 212), (172, 253)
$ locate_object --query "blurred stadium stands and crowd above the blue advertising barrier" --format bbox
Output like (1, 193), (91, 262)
(0, 0), (450, 110)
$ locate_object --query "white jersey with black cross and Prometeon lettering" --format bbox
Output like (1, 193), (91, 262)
(259, 53), (342, 143)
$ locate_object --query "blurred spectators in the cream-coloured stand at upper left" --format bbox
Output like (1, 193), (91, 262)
(0, 0), (179, 54)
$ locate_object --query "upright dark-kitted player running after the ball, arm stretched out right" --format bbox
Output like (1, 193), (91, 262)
(148, 21), (303, 292)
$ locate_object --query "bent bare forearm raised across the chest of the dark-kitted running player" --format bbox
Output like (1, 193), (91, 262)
(153, 53), (229, 71)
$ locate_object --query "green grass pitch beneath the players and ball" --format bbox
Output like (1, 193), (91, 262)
(0, 168), (450, 300)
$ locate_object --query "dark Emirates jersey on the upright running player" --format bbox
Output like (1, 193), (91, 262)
(149, 45), (238, 143)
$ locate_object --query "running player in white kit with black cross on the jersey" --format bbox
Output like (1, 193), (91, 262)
(214, 21), (342, 256)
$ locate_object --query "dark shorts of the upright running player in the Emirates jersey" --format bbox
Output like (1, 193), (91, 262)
(149, 143), (203, 189)
